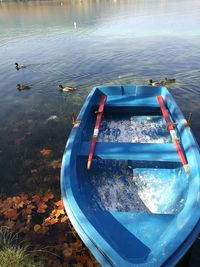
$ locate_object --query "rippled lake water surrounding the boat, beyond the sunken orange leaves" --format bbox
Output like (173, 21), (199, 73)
(0, 0), (200, 266)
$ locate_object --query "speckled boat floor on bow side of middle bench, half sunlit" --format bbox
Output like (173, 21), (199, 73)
(90, 160), (187, 214)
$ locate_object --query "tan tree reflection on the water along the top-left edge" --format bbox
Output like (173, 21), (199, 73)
(0, 0), (126, 28)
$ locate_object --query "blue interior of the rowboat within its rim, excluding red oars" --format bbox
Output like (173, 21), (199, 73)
(63, 86), (198, 266)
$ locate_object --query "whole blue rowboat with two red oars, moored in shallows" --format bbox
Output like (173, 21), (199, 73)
(61, 85), (200, 267)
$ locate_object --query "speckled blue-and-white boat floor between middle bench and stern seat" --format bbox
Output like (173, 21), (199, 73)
(98, 116), (171, 143)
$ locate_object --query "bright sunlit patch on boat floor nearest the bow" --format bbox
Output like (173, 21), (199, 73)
(132, 168), (187, 214)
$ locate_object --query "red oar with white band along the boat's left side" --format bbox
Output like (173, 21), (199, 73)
(87, 96), (106, 170)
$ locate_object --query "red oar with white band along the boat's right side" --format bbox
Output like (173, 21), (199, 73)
(156, 96), (189, 173)
